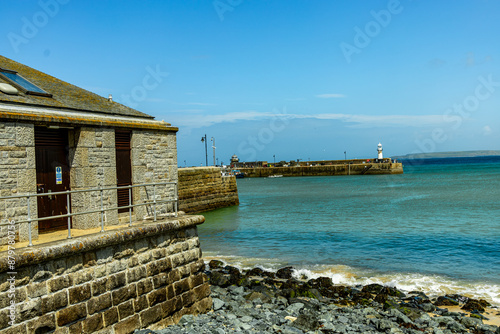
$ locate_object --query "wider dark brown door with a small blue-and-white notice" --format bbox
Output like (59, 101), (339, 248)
(35, 127), (70, 233)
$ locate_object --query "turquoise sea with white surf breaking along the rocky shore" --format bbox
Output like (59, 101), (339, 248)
(198, 157), (500, 305)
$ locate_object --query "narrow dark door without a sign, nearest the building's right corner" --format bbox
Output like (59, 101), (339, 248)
(115, 130), (132, 212)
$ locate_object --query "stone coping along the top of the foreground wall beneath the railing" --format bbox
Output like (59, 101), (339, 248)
(0, 215), (205, 273)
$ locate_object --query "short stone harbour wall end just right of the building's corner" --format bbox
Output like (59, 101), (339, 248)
(178, 167), (239, 213)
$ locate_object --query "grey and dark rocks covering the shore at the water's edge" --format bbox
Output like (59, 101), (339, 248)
(135, 260), (500, 334)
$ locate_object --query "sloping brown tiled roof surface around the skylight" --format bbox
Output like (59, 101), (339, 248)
(0, 55), (154, 119)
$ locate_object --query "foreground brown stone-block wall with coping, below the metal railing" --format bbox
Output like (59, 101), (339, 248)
(0, 216), (212, 334)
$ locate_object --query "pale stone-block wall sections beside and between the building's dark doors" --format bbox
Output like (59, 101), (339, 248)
(0, 122), (177, 245)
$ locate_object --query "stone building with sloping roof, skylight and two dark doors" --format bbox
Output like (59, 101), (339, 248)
(0, 56), (178, 245)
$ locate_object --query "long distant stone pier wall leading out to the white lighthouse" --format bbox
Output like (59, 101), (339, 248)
(239, 162), (403, 177)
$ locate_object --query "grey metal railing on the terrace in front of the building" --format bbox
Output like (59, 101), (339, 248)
(0, 182), (179, 247)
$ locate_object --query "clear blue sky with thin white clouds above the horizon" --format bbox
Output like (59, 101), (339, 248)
(0, 0), (500, 166)
